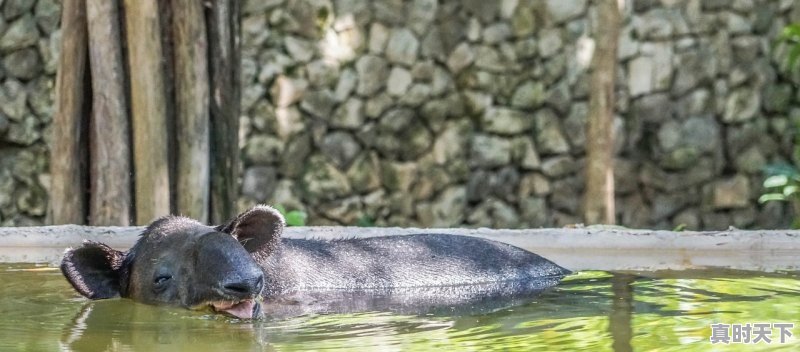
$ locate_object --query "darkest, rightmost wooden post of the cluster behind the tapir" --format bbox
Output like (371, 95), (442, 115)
(206, 0), (241, 223)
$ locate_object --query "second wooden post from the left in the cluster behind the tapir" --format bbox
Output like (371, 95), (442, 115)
(86, 0), (131, 225)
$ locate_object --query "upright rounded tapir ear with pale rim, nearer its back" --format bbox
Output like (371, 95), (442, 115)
(217, 205), (286, 255)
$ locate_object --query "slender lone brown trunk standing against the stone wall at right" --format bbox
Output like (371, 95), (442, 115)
(583, 1), (620, 224)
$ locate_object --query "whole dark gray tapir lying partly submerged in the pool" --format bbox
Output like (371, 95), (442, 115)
(61, 206), (569, 318)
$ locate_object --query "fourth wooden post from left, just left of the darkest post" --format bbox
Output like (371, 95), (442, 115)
(170, 0), (211, 223)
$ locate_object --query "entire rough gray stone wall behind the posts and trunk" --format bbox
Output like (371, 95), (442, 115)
(0, 0), (800, 229)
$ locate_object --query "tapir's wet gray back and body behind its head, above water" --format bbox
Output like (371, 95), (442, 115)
(261, 234), (569, 296)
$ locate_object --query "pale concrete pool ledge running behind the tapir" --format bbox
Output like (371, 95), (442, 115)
(0, 225), (800, 271)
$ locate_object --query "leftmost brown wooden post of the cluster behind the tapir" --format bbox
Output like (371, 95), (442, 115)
(50, 0), (87, 224)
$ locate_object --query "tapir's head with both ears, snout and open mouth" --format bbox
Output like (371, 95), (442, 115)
(61, 206), (285, 318)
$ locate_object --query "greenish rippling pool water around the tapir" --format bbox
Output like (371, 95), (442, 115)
(0, 264), (800, 352)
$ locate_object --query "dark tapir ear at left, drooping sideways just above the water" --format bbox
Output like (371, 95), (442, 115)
(61, 241), (125, 299)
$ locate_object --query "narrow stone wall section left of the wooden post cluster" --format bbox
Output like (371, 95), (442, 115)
(0, 0), (61, 226)
